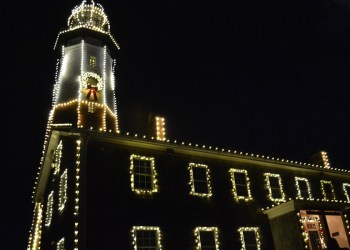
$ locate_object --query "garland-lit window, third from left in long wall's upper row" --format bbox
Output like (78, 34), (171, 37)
(230, 168), (252, 201)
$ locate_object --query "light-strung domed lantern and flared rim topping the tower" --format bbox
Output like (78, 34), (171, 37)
(54, 0), (119, 49)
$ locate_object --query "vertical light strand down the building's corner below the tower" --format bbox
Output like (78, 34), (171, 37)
(74, 140), (81, 250)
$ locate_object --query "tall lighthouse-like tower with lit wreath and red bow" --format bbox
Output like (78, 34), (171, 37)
(49, 0), (119, 133)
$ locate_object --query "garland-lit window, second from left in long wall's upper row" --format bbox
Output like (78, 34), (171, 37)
(189, 163), (212, 197)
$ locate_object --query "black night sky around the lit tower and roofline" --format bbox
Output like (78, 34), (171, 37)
(4, 0), (350, 250)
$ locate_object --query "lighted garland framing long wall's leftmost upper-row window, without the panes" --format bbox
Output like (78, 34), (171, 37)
(130, 154), (158, 194)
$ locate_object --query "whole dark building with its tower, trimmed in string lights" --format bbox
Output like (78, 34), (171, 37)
(27, 1), (350, 250)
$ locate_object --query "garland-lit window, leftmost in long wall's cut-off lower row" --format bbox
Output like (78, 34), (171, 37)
(131, 226), (162, 250)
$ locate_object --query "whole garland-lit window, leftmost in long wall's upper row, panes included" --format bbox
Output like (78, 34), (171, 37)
(130, 155), (158, 194)
